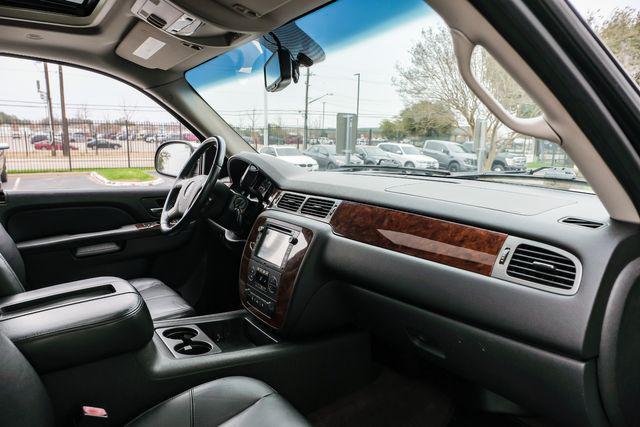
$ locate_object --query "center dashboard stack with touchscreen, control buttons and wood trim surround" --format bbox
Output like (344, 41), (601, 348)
(239, 217), (313, 329)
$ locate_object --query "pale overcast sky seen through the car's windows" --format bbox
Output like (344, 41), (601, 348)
(0, 0), (640, 128)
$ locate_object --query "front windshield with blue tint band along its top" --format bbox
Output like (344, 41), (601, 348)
(185, 0), (589, 191)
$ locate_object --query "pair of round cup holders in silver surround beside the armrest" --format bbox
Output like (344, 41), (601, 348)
(156, 325), (221, 358)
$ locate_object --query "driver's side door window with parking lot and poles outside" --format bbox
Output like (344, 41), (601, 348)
(0, 57), (197, 190)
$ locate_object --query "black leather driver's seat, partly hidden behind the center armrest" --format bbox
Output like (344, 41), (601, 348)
(0, 225), (194, 320)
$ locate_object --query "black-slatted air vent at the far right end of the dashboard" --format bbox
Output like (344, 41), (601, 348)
(507, 244), (577, 289)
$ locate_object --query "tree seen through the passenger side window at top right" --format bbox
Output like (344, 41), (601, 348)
(588, 7), (640, 84)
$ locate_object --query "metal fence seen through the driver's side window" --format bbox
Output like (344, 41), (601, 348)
(0, 119), (196, 173)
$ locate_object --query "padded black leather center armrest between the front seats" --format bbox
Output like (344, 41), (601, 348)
(0, 277), (153, 373)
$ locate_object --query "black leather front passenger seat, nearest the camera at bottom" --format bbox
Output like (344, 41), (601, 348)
(0, 334), (309, 427)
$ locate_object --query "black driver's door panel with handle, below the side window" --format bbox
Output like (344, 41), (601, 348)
(0, 187), (199, 289)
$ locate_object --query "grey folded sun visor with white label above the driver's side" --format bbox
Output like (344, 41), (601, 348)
(116, 22), (201, 70)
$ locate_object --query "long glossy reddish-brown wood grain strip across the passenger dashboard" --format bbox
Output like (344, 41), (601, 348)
(330, 202), (507, 276)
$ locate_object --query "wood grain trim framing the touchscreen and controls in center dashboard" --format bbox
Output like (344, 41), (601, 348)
(239, 217), (313, 329)
